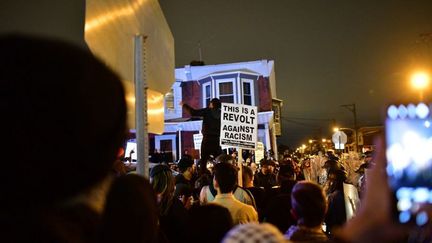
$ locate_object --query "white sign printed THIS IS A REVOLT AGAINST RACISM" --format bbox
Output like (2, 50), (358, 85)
(220, 103), (258, 149)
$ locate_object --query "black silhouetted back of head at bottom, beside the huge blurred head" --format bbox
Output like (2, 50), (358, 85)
(99, 174), (158, 242)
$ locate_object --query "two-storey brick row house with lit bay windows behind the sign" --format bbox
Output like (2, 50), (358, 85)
(150, 60), (282, 161)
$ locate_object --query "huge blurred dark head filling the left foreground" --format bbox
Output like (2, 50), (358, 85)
(0, 35), (127, 207)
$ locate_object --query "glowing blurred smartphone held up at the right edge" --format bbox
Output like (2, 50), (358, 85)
(385, 103), (432, 226)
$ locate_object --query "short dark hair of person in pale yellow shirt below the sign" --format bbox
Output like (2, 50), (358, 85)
(214, 163), (237, 193)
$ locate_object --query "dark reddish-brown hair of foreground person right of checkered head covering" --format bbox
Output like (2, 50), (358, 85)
(291, 181), (327, 227)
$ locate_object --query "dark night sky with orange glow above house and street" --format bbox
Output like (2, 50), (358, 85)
(159, 0), (432, 146)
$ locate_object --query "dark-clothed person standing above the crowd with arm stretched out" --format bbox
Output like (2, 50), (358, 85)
(180, 98), (222, 171)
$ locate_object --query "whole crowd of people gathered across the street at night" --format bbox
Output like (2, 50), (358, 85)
(0, 35), (431, 243)
